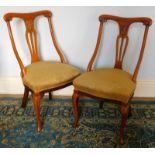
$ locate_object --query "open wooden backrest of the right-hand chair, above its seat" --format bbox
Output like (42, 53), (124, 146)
(87, 15), (152, 81)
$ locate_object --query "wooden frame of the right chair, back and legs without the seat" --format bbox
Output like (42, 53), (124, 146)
(72, 15), (152, 144)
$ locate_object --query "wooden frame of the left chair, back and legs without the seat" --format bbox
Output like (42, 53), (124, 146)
(4, 10), (72, 132)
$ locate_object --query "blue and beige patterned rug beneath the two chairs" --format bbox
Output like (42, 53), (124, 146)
(0, 97), (155, 148)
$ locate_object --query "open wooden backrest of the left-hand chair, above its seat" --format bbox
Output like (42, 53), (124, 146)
(4, 10), (65, 77)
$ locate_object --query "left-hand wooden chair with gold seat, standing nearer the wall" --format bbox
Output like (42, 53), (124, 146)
(4, 10), (80, 132)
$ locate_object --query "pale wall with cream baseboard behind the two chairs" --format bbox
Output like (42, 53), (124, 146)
(0, 6), (155, 97)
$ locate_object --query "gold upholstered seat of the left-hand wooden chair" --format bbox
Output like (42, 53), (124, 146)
(23, 61), (80, 92)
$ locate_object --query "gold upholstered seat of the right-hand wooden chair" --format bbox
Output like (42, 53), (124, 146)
(73, 68), (136, 103)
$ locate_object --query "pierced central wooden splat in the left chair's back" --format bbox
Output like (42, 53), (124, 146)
(24, 19), (39, 62)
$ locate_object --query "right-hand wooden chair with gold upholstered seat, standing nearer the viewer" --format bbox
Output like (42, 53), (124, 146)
(73, 15), (152, 144)
